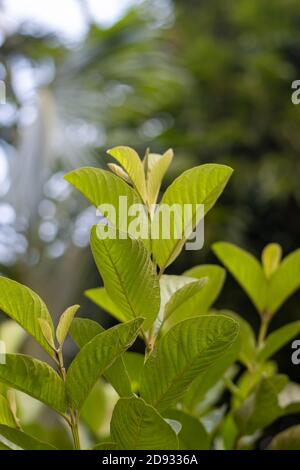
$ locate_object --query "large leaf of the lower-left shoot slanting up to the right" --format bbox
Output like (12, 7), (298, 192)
(66, 318), (143, 410)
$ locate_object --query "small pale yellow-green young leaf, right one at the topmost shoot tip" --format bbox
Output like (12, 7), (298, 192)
(146, 149), (173, 206)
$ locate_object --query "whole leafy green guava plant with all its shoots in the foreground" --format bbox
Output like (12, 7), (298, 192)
(0, 147), (300, 450)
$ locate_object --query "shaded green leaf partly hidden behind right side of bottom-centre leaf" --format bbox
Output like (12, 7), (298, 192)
(165, 410), (210, 450)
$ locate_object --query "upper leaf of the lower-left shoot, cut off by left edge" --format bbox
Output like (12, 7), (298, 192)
(0, 277), (54, 356)
